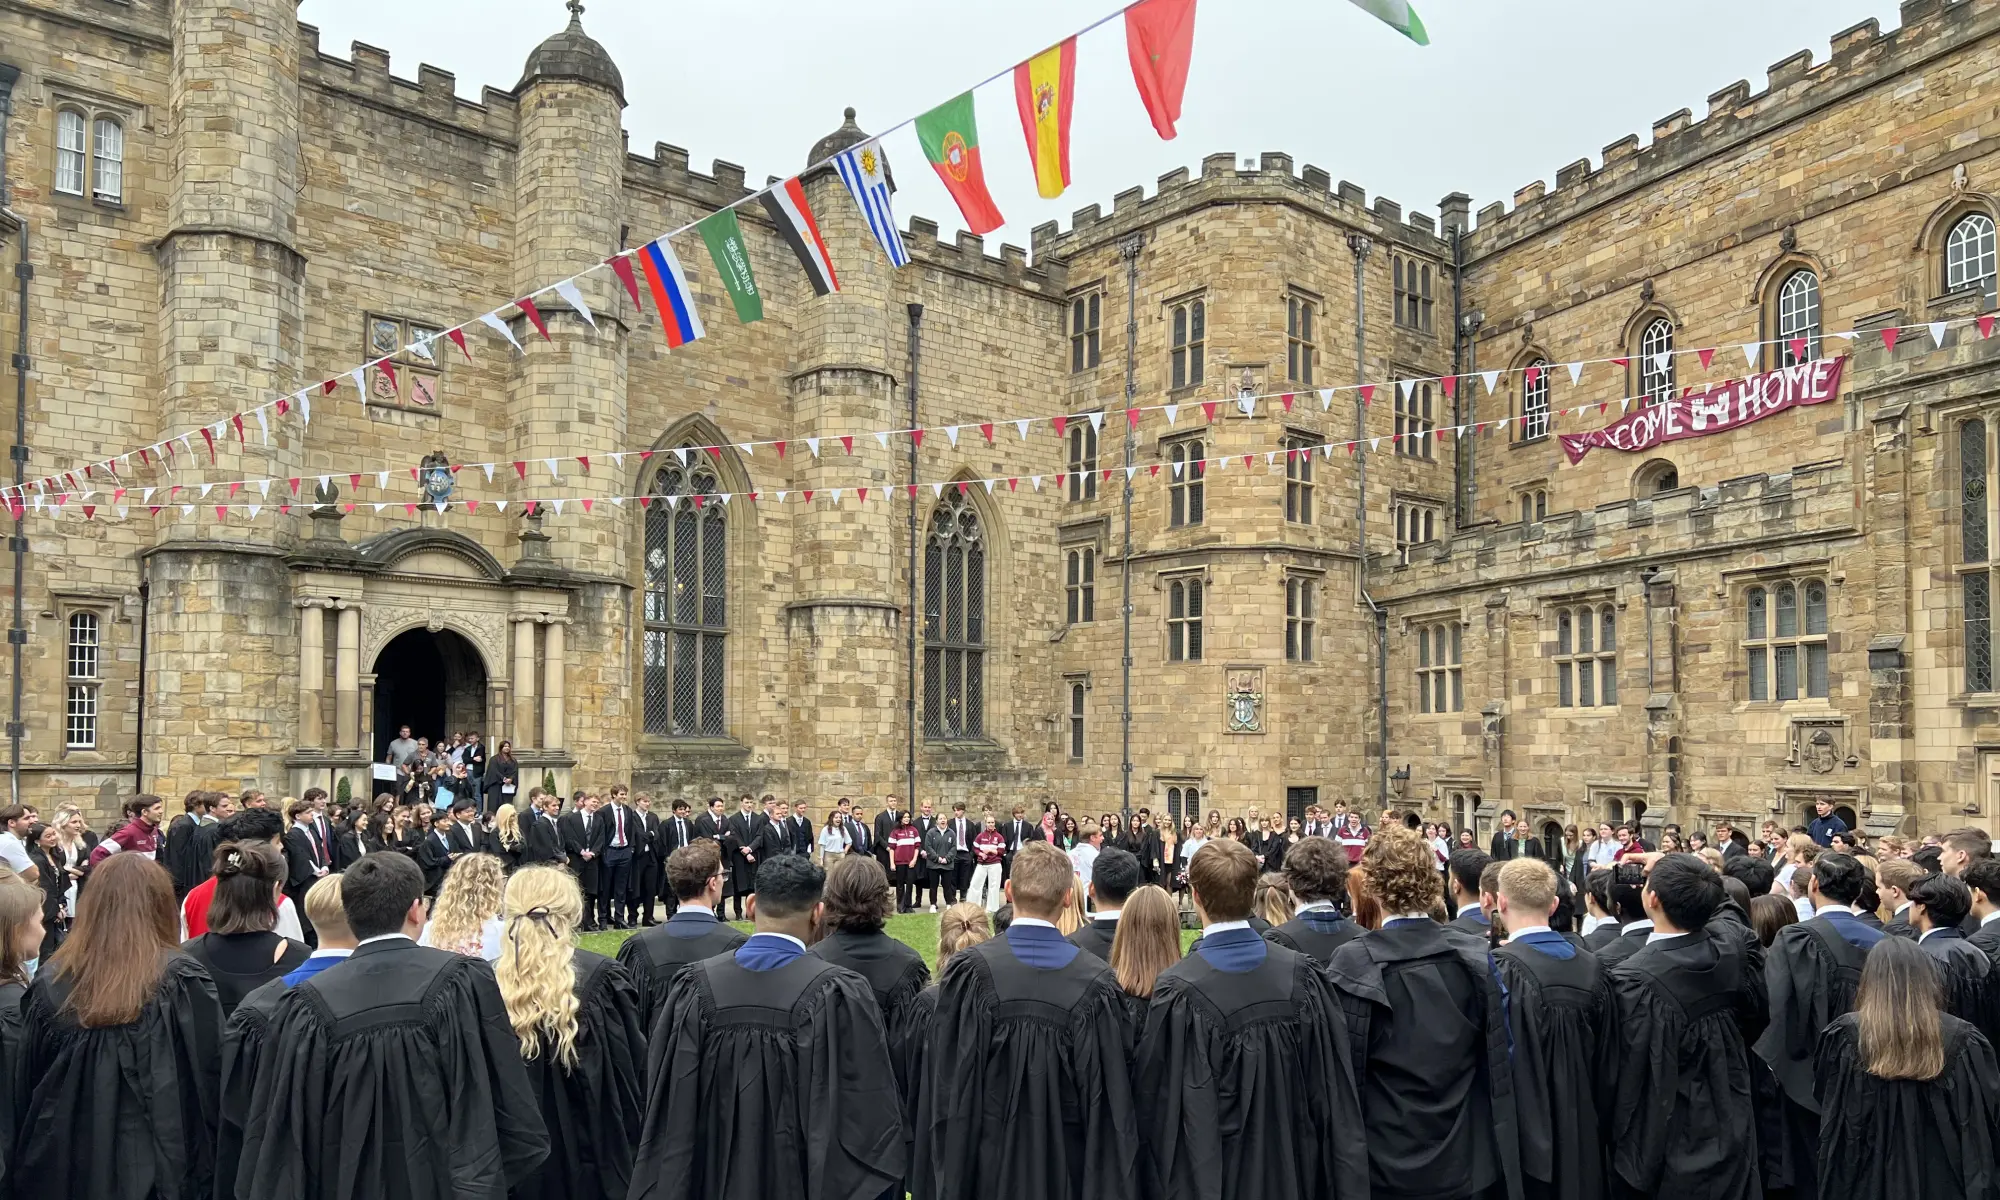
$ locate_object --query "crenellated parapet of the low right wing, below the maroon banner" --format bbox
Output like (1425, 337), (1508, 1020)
(1370, 460), (1860, 600)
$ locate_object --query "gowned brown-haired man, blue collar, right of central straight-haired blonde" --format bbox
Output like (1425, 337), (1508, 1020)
(1132, 840), (1368, 1200)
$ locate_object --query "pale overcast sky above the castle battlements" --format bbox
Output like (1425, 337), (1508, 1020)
(300, 0), (1898, 250)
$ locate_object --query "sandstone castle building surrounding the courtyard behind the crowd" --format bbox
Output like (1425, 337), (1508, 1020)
(0, 0), (2000, 848)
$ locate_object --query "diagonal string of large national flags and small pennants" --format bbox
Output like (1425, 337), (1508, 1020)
(38, 0), (1428, 504)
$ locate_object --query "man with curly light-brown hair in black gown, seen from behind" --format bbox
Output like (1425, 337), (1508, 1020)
(1326, 826), (1520, 1200)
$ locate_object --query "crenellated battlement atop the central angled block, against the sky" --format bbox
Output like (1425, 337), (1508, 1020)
(1030, 152), (1464, 262)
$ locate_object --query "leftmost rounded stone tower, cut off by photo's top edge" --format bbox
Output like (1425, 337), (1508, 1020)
(142, 0), (304, 794)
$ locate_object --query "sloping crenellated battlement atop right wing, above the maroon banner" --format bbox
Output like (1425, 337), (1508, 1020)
(1468, 0), (2000, 258)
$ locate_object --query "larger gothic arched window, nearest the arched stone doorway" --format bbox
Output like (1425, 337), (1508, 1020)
(646, 446), (728, 738)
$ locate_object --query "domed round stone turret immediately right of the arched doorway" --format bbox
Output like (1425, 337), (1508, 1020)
(510, 0), (632, 770)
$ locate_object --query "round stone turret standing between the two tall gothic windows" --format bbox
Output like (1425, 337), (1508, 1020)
(788, 108), (928, 796)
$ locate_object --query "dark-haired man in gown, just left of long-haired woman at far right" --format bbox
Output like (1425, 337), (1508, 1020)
(1752, 850), (1886, 1196)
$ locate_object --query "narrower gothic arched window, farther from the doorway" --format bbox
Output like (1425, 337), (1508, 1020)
(924, 492), (986, 738)
